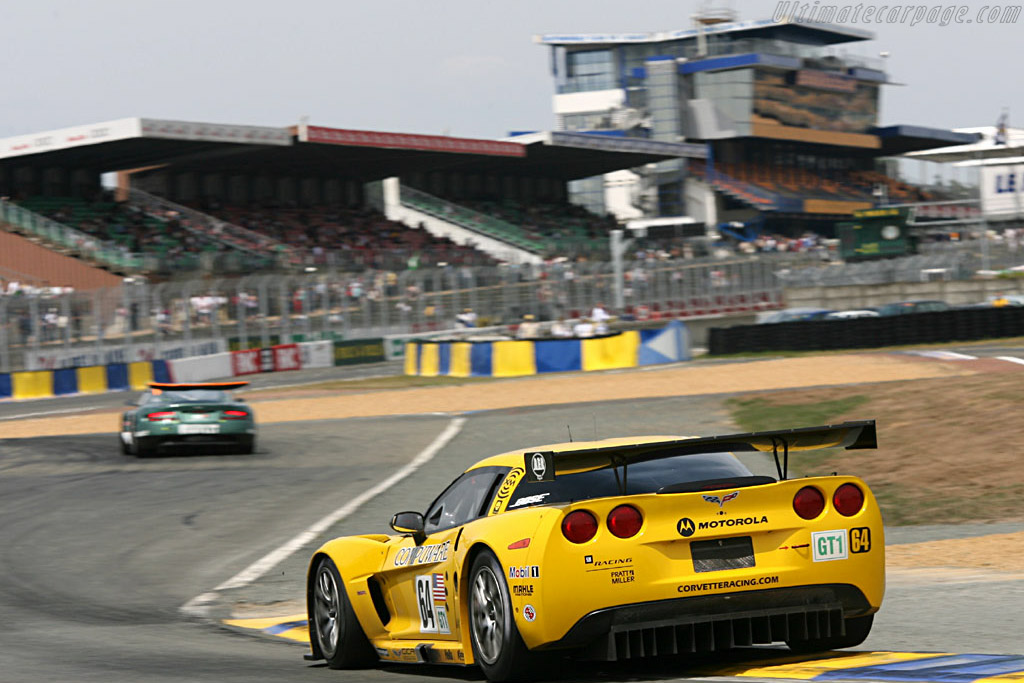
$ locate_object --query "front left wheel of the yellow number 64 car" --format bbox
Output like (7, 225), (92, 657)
(308, 557), (377, 669)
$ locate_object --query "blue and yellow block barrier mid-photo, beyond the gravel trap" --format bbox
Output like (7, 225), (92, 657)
(406, 322), (690, 377)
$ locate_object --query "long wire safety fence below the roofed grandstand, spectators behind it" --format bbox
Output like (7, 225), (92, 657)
(0, 259), (782, 373)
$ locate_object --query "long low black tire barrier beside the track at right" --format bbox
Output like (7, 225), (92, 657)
(708, 307), (1024, 355)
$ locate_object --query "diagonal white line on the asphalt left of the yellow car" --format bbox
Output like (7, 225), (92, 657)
(181, 417), (466, 615)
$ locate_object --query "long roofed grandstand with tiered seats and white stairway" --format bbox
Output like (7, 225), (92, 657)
(0, 119), (705, 286)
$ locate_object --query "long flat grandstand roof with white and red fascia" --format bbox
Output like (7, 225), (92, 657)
(0, 118), (705, 182)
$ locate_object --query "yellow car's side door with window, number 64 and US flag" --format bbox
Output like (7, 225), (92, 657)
(383, 467), (508, 641)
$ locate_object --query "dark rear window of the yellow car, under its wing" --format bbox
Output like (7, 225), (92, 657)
(506, 453), (752, 510)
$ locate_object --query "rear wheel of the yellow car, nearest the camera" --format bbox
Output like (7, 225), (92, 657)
(469, 550), (537, 681)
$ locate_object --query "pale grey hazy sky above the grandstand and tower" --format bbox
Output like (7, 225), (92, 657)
(0, 0), (1024, 138)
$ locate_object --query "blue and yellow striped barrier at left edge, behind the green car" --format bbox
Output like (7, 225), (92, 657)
(0, 360), (171, 399)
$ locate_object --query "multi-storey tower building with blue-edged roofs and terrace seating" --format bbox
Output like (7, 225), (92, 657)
(536, 10), (975, 239)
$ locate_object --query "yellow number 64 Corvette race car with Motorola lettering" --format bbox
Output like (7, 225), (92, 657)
(306, 421), (885, 681)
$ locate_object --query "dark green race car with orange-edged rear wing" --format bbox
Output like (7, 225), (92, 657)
(121, 382), (256, 458)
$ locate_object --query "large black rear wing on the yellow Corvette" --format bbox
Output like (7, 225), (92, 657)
(524, 420), (878, 481)
